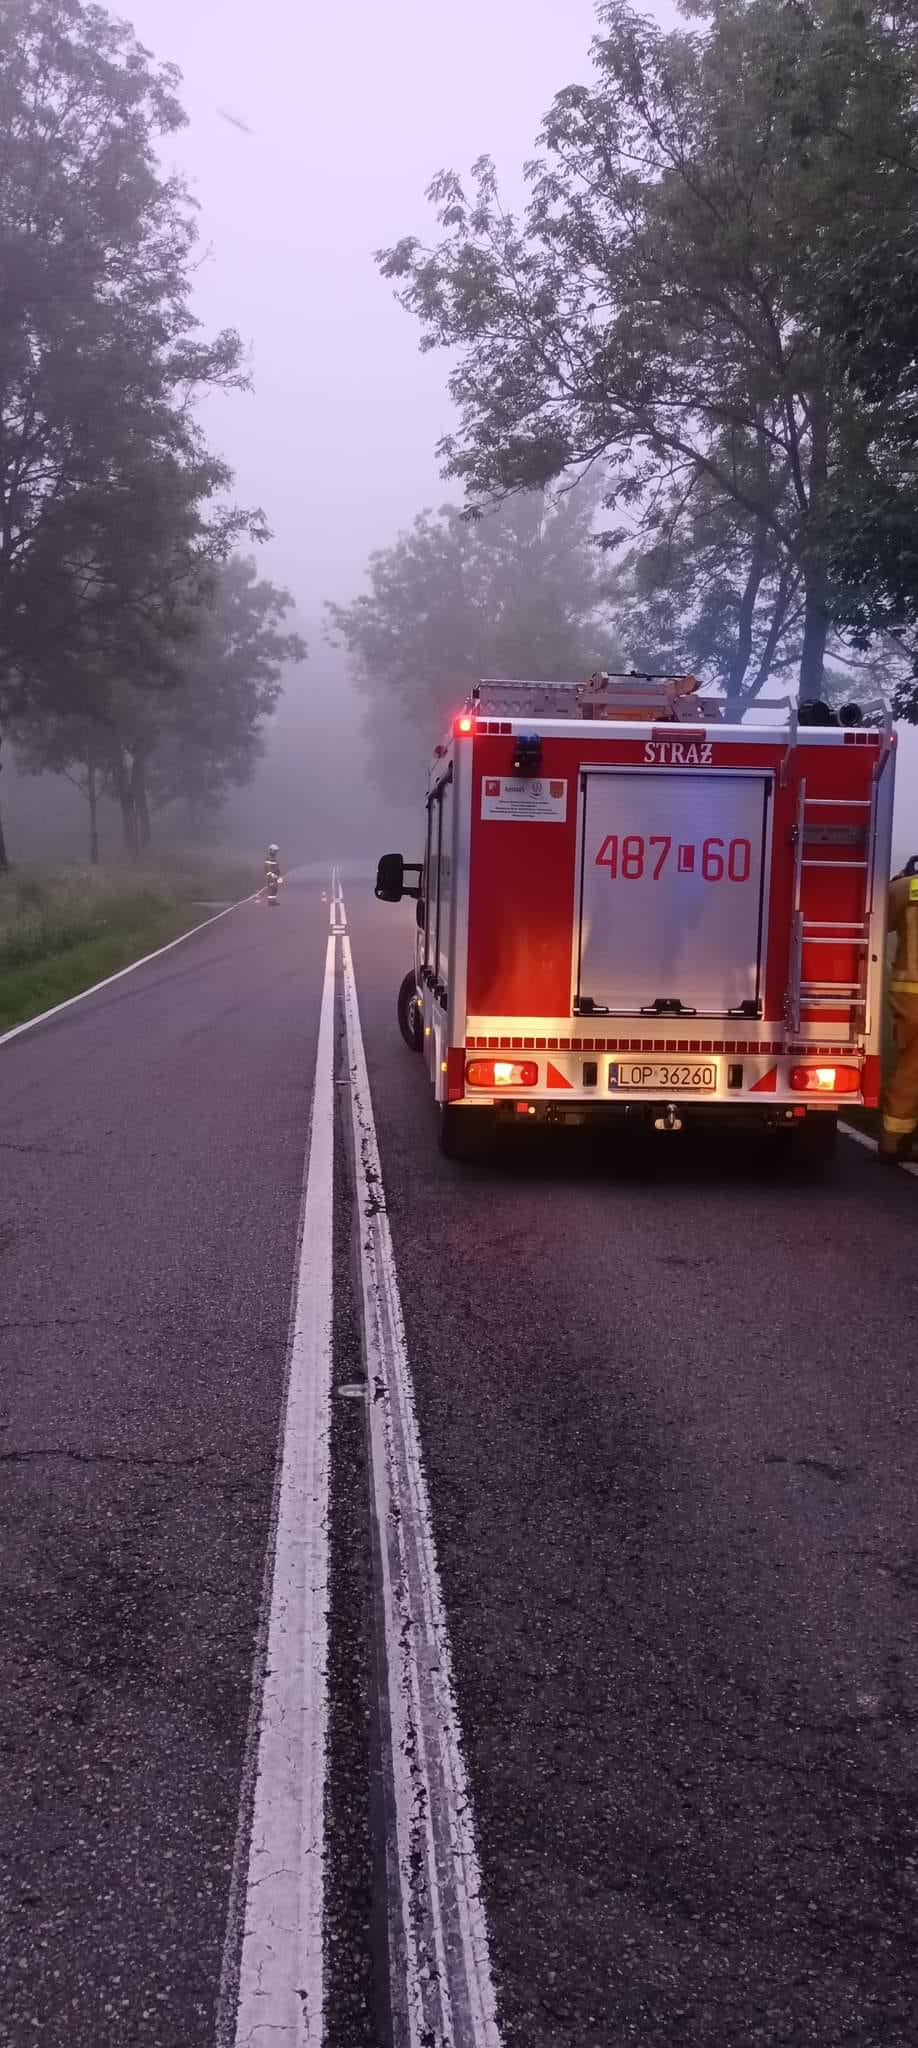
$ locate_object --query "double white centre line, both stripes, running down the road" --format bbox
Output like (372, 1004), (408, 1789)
(217, 874), (500, 2048)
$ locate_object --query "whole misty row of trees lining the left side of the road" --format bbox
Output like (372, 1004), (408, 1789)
(0, 0), (305, 864)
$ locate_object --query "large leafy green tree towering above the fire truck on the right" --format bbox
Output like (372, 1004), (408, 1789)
(381, 0), (918, 698)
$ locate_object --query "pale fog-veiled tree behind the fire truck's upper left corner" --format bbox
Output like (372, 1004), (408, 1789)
(328, 485), (617, 797)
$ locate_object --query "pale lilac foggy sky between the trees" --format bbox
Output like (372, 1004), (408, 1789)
(2, 0), (918, 858)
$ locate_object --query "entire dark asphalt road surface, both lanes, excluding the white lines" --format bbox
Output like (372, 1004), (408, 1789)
(0, 887), (918, 2048)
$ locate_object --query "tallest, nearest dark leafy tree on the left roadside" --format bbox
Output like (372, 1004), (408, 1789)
(0, 0), (262, 856)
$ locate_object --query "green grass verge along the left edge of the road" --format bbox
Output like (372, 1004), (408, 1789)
(0, 856), (260, 1032)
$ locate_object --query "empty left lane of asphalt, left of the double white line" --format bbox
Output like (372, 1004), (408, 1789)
(0, 897), (328, 2048)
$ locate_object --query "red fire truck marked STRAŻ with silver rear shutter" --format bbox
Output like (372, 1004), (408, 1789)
(375, 676), (895, 1161)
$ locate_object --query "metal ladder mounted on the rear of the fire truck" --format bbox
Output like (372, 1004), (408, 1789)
(785, 721), (891, 1044)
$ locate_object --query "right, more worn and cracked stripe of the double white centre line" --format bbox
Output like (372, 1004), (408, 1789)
(342, 938), (500, 2048)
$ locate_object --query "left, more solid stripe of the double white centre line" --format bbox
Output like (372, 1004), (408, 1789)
(228, 938), (336, 2048)
